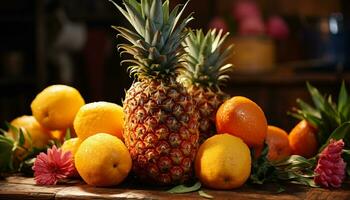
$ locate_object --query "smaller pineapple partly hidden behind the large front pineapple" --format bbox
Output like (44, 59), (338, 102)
(178, 29), (233, 143)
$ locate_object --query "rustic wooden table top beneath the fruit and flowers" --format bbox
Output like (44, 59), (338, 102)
(0, 176), (350, 200)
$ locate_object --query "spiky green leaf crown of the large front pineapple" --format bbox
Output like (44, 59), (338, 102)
(110, 0), (193, 79)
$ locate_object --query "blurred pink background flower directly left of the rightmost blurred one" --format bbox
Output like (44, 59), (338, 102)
(238, 17), (265, 36)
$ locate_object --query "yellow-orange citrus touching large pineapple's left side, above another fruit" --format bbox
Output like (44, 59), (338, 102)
(74, 101), (124, 140)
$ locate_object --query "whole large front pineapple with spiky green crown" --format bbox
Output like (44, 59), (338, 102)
(110, 0), (199, 185)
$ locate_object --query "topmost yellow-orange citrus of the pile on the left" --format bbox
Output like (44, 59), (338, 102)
(31, 85), (85, 130)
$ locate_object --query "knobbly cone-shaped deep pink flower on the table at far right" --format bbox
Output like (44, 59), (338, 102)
(314, 139), (346, 188)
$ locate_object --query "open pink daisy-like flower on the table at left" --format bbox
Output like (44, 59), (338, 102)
(32, 146), (75, 185)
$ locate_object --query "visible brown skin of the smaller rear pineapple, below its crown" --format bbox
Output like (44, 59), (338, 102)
(188, 86), (228, 144)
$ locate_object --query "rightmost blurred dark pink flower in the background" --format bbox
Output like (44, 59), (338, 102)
(266, 16), (289, 40)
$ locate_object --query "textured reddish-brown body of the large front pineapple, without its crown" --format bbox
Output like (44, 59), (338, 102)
(123, 77), (199, 185)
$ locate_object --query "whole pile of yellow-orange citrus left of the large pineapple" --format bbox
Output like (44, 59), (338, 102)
(3, 85), (131, 186)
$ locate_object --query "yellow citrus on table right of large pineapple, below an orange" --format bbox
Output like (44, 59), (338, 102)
(195, 134), (251, 189)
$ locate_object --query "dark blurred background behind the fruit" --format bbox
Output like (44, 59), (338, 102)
(0, 0), (350, 131)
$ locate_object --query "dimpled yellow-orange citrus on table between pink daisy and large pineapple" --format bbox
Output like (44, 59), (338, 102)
(75, 133), (132, 186)
